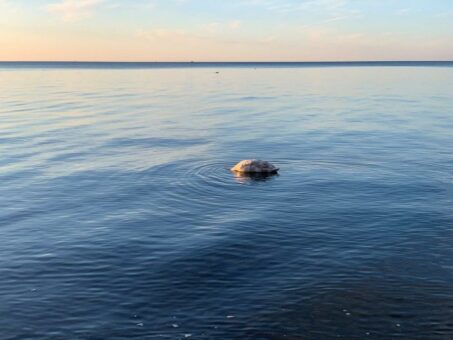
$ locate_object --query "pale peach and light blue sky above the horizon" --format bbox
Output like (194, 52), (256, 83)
(0, 0), (453, 61)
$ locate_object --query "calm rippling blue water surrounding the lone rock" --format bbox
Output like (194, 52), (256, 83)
(0, 63), (453, 339)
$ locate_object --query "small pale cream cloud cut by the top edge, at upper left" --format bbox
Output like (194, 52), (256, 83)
(47, 0), (105, 21)
